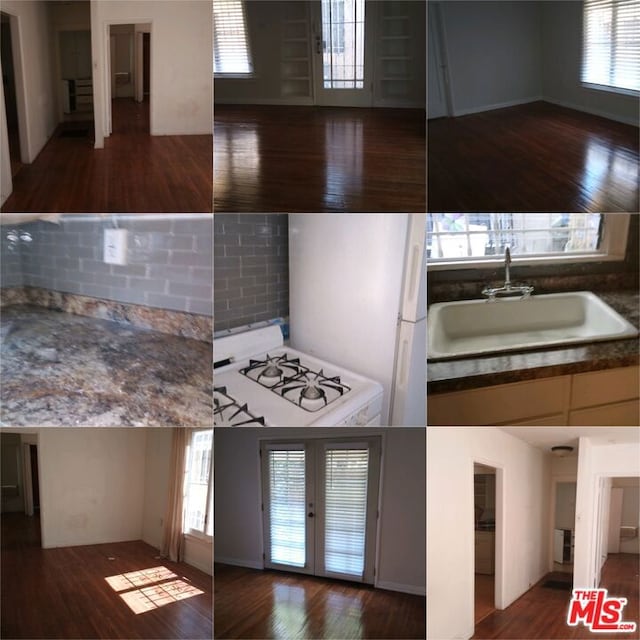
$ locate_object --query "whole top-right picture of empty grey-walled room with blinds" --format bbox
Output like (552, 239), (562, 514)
(427, 0), (640, 212)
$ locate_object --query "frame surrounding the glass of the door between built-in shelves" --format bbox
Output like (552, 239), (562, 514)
(309, 0), (378, 107)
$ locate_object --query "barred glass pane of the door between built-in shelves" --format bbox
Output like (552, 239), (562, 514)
(322, 0), (365, 89)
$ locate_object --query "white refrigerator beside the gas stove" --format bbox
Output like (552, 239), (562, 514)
(289, 213), (427, 426)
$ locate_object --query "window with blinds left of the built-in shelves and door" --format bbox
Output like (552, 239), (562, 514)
(213, 0), (253, 76)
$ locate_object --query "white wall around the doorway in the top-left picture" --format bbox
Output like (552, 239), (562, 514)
(91, 0), (213, 147)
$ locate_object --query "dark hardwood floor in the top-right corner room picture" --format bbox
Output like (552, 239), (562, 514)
(427, 102), (640, 212)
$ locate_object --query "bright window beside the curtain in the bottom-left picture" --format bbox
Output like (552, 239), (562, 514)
(184, 429), (213, 536)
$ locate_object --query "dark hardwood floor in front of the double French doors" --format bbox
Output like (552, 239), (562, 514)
(214, 564), (426, 640)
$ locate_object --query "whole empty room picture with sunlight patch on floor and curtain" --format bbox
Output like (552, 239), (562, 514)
(0, 428), (213, 639)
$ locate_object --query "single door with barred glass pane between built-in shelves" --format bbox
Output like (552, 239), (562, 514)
(313, 0), (374, 107)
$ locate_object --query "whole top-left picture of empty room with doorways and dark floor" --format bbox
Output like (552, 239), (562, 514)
(0, 0), (213, 213)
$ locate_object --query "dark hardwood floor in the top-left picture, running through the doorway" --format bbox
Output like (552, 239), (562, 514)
(2, 99), (213, 213)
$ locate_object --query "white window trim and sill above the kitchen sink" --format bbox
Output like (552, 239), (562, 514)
(427, 213), (631, 271)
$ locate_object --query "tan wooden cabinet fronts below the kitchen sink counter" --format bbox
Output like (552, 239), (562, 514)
(427, 367), (640, 426)
